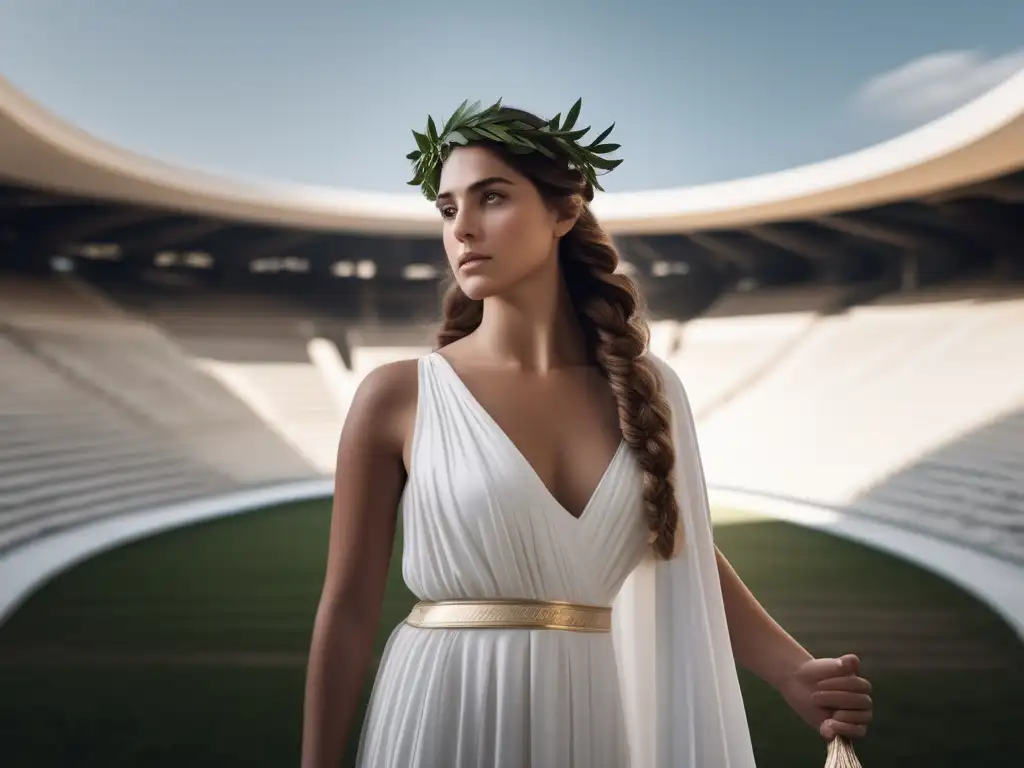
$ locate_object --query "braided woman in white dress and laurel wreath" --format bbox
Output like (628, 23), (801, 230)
(303, 102), (871, 768)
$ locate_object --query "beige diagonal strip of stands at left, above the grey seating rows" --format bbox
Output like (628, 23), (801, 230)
(0, 276), (317, 486)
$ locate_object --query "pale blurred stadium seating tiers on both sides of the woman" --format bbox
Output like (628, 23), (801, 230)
(0, 268), (1024, 561)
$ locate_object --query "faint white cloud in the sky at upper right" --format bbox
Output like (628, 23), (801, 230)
(854, 49), (1024, 123)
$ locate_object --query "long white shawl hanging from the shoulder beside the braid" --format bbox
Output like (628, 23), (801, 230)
(612, 355), (754, 768)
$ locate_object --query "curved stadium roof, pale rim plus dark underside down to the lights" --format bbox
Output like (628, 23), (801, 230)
(0, 72), (1024, 296)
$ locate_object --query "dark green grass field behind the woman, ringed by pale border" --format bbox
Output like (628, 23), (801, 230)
(0, 502), (1024, 768)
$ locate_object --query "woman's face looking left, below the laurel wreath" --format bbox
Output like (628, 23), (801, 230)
(436, 146), (572, 299)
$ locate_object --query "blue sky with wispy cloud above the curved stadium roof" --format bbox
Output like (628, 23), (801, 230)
(0, 0), (1024, 193)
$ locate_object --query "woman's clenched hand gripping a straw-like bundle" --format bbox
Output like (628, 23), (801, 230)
(778, 654), (873, 741)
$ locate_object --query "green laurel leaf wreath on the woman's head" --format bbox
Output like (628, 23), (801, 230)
(406, 98), (623, 201)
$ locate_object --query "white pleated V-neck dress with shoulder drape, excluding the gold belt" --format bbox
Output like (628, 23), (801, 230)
(358, 353), (754, 768)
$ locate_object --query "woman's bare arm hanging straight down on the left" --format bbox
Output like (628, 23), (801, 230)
(301, 360), (417, 768)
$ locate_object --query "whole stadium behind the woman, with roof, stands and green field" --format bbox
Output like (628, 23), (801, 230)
(0, 63), (1024, 768)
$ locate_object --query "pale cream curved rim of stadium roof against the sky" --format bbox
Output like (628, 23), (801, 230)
(0, 72), (1024, 234)
